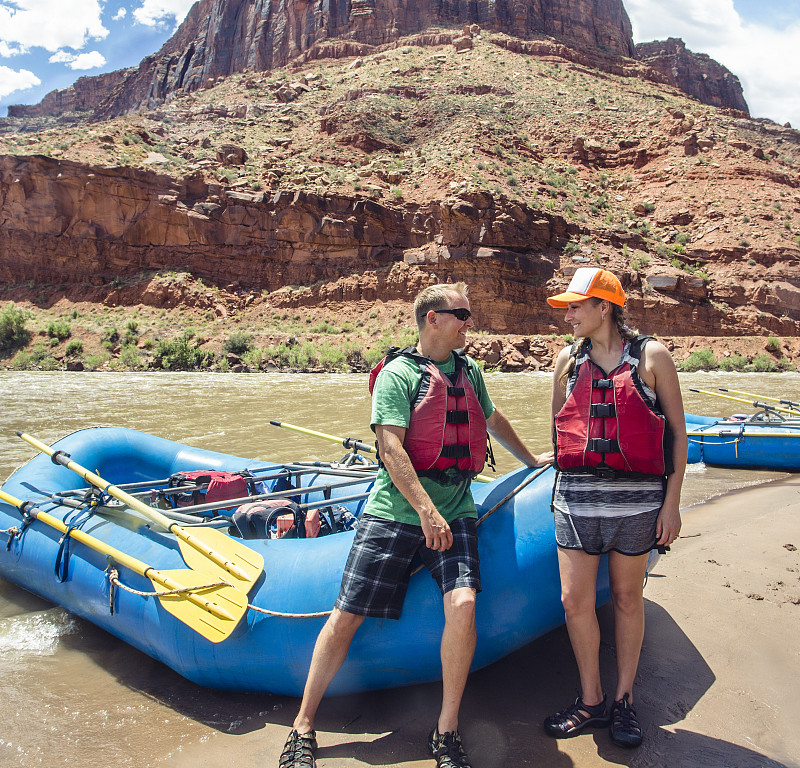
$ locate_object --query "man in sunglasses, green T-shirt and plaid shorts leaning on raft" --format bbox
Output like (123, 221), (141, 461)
(280, 283), (552, 768)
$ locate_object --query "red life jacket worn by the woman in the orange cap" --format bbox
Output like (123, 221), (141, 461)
(553, 336), (674, 478)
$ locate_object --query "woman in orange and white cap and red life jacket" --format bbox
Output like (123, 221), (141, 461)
(544, 267), (687, 747)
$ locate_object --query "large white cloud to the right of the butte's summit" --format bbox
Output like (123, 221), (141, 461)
(625, 0), (800, 127)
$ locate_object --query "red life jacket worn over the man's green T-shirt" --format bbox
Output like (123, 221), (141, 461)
(370, 347), (488, 480)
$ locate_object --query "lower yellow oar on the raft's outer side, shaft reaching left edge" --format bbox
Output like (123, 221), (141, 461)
(0, 490), (247, 643)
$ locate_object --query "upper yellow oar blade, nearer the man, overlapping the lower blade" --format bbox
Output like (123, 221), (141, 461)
(173, 526), (264, 593)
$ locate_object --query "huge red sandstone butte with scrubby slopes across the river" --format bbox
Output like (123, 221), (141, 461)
(0, 0), (800, 370)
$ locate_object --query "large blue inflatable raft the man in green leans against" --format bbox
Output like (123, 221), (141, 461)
(0, 427), (657, 695)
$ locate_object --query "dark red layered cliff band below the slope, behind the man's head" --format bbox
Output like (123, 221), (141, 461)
(0, 156), (567, 332)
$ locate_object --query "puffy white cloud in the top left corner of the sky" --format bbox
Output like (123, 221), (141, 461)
(0, 0), (108, 51)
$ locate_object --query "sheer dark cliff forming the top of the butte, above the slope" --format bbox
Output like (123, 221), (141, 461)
(10, 0), (634, 119)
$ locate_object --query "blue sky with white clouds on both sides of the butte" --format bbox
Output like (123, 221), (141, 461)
(0, 0), (800, 128)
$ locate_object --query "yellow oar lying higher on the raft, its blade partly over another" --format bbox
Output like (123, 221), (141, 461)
(17, 432), (264, 593)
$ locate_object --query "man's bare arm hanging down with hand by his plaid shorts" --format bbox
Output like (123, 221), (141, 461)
(375, 424), (453, 552)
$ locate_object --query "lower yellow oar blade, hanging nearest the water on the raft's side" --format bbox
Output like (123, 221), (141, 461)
(147, 560), (247, 643)
